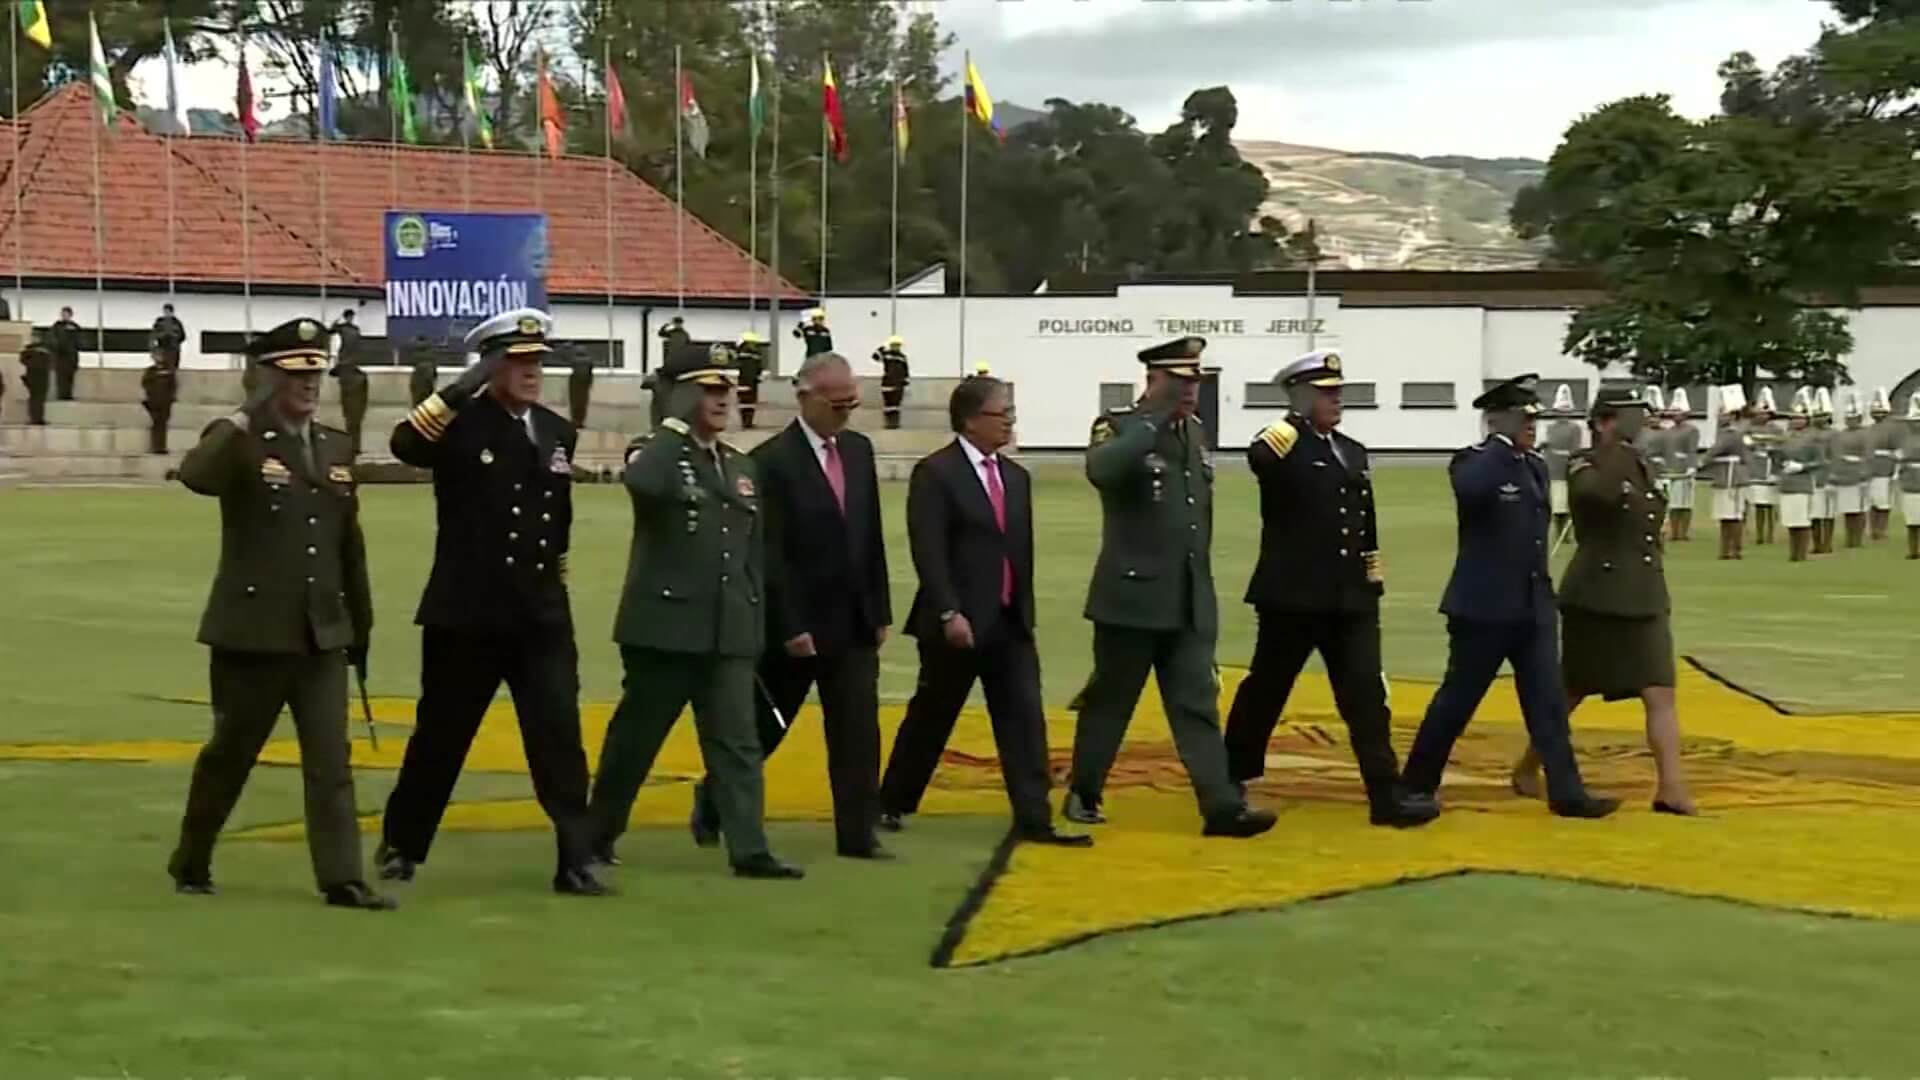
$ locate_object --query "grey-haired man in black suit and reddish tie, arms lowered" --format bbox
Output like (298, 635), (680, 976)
(693, 352), (893, 859)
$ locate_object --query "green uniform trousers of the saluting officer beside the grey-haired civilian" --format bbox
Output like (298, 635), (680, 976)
(588, 646), (766, 865)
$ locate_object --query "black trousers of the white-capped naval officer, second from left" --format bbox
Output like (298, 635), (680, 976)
(382, 626), (588, 871)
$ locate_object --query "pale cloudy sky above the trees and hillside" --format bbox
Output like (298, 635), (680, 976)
(136, 0), (1832, 158)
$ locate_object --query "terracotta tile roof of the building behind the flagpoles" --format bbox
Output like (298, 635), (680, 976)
(0, 83), (806, 298)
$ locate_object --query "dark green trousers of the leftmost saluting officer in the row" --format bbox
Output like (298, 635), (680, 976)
(177, 650), (365, 888)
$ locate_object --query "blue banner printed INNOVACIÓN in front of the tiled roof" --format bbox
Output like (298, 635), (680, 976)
(386, 209), (547, 348)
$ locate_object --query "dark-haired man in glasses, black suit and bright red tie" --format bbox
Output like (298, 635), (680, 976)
(879, 375), (1092, 847)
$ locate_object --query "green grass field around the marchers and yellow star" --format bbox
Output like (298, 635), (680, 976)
(0, 467), (1920, 1080)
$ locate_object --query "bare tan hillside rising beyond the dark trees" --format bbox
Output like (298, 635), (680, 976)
(1235, 140), (1546, 269)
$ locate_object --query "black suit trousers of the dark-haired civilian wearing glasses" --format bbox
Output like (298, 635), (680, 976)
(879, 611), (1052, 832)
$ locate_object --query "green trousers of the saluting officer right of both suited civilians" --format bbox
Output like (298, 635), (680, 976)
(1071, 623), (1242, 819)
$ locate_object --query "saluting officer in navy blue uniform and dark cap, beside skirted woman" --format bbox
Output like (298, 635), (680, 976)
(1405, 375), (1619, 817)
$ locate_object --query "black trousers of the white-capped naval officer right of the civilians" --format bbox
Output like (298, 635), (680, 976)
(1227, 607), (1400, 809)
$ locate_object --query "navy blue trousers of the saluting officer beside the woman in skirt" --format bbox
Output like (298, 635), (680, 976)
(1405, 617), (1586, 801)
